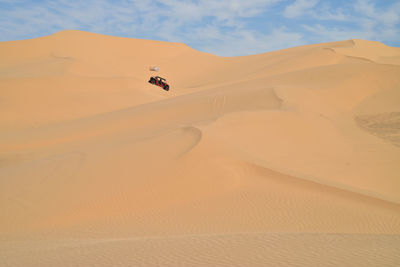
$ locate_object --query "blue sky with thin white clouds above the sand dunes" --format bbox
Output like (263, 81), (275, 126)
(0, 0), (400, 56)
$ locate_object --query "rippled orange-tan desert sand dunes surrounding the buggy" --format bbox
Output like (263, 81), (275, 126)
(0, 31), (400, 267)
